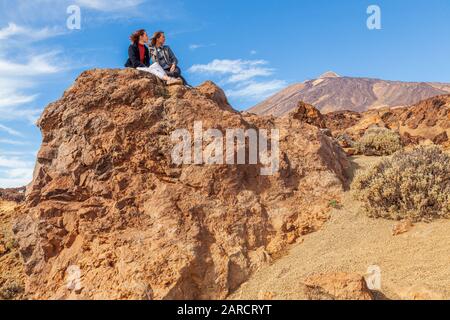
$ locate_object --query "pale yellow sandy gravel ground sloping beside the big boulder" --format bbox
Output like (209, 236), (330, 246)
(231, 157), (450, 300)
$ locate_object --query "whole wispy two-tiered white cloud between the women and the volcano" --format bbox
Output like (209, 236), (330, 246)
(189, 59), (287, 100)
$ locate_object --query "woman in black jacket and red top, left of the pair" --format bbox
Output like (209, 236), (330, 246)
(125, 29), (183, 85)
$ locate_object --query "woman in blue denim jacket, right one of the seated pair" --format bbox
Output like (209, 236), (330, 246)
(150, 31), (187, 84)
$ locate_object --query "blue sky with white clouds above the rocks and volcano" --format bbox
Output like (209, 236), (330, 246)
(0, 0), (450, 187)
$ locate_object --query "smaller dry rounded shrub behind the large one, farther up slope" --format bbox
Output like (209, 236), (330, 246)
(355, 127), (402, 156)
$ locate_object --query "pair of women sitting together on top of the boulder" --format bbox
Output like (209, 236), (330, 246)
(125, 29), (186, 85)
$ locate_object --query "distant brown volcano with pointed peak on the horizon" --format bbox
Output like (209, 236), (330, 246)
(249, 72), (450, 116)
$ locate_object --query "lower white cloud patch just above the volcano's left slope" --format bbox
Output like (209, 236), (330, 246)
(227, 80), (287, 100)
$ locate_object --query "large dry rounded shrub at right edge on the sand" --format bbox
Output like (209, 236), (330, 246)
(352, 146), (450, 221)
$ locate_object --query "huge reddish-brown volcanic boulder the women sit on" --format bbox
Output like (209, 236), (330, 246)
(14, 70), (348, 299)
